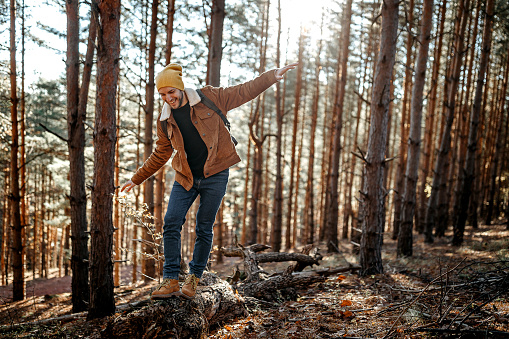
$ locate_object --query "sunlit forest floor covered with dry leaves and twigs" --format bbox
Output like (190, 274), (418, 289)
(0, 224), (509, 339)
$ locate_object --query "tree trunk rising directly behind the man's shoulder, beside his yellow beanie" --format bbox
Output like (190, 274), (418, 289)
(207, 0), (225, 87)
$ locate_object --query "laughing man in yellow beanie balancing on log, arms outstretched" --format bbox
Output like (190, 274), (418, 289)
(121, 63), (297, 299)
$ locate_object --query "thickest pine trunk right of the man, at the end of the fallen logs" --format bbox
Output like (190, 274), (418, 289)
(360, 0), (399, 275)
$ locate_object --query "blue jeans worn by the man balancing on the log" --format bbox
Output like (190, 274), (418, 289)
(163, 169), (229, 279)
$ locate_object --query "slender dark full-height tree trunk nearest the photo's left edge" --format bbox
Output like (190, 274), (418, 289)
(9, 0), (25, 301)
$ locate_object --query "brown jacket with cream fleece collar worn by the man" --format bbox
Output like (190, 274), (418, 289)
(131, 70), (276, 191)
